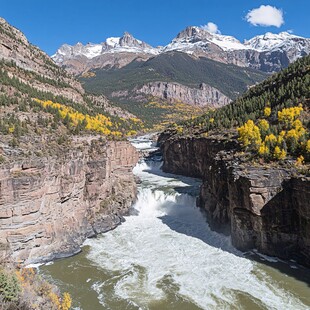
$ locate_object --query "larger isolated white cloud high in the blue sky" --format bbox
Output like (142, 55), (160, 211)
(245, 5), (284, 28)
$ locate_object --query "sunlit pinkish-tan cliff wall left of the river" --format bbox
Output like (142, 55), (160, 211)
(0, 140), (138, 263)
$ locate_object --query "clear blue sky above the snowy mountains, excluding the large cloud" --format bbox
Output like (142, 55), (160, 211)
(0, 0), (310, 55)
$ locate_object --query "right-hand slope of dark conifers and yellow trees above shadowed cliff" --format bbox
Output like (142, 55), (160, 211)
(162, 56), (310, 160)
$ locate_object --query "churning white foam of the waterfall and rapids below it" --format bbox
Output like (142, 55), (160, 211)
(85, 156), (307, 309)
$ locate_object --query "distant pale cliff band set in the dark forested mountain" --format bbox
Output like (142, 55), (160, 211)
(134, 82), (231, 108)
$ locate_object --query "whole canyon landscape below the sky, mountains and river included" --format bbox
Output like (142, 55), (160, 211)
(0, 5), (310, 310)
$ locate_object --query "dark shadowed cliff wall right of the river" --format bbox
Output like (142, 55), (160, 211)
(160, 136), (310, 266)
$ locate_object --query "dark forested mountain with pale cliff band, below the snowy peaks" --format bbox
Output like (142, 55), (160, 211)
(80, 52), (266, 123)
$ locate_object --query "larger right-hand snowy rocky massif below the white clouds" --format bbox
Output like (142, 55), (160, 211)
(163, 27), (310, 72)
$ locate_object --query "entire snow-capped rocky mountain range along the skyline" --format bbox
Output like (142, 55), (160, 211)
(52, 26), (310, 74)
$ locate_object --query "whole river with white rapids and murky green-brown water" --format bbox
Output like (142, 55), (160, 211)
(40, 138), (310, 310)
